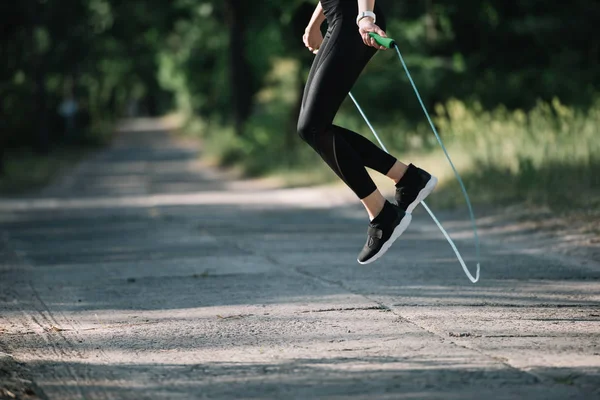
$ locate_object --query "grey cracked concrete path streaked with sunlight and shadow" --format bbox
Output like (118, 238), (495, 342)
(0, 124), (600, 400)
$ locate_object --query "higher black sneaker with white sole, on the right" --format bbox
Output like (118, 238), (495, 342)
(394, 164), (437, 214)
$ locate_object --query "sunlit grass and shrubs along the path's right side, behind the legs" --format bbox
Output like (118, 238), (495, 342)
(185, 60), (600, 213)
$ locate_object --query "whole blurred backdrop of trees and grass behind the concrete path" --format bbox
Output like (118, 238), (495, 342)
(0, 0), (600, 210)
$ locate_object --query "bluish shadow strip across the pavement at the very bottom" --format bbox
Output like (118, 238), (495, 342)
(21, 357), (600, 400)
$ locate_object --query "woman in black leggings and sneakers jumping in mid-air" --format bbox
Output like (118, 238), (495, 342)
(298, 0), (437, 264)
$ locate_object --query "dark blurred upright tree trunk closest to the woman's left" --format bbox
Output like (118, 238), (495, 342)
(226, 0), (252, 136)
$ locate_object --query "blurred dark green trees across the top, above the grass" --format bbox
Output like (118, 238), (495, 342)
(0, 0), (600, 177)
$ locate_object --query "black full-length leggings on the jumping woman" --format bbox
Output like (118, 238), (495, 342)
(298, 0), (396, 199)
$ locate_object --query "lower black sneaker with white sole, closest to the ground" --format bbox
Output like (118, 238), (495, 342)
(357, 201), (412, 264)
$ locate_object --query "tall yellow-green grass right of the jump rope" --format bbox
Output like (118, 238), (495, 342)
(424, 99), (600, 211)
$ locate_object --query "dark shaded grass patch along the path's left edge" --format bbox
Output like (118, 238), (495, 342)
(0, 147), (89, 196)
